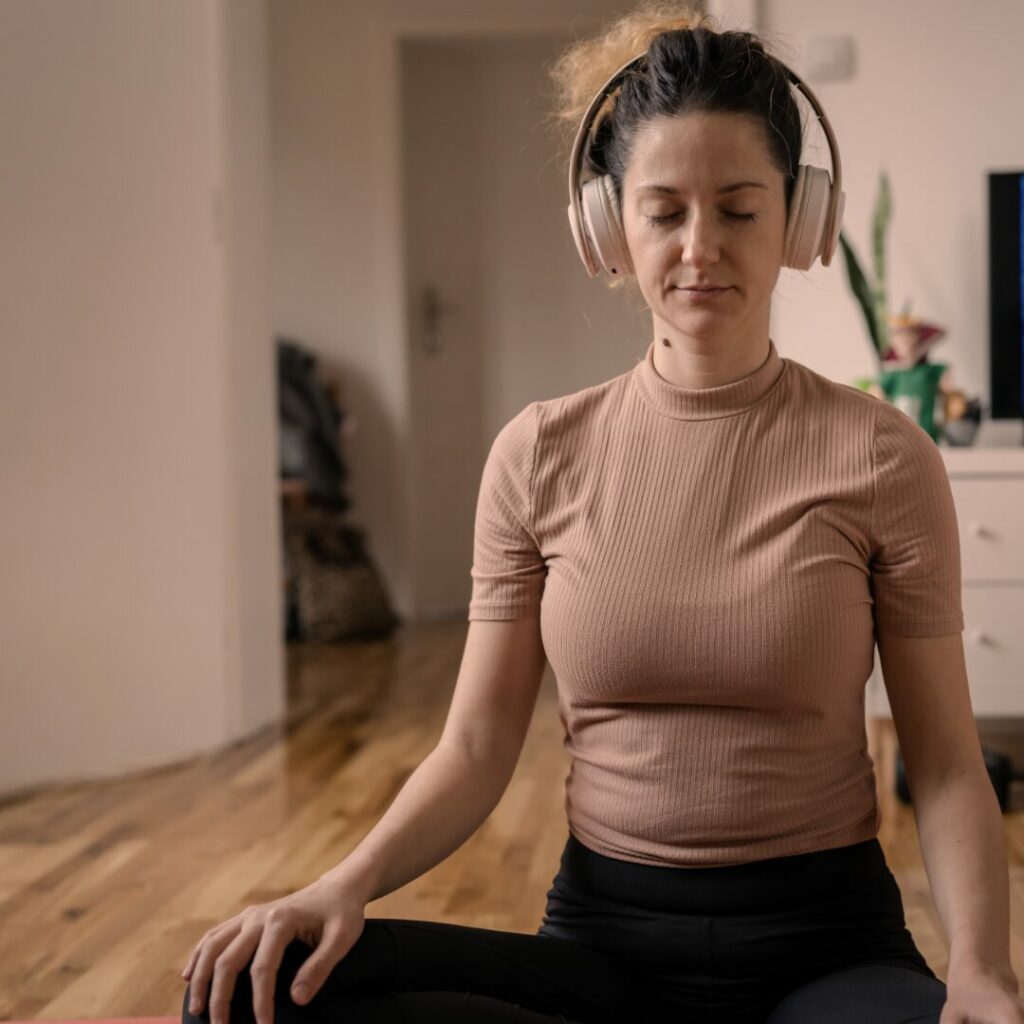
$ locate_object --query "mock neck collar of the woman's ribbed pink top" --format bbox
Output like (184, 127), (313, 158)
(633, 338), (785, 420)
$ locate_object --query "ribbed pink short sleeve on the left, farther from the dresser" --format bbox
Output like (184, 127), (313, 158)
(469, 401), (547, 620)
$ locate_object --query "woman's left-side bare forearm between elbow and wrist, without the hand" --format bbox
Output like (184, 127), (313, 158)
(321, 744), (515, 903)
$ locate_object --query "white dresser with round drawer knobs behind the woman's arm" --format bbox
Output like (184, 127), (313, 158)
(865, 446), (1024, 718)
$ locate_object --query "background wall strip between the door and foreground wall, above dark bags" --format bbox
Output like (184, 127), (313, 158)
(269, 0), (412, 609)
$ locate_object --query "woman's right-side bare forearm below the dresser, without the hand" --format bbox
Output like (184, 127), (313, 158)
(914, 773), (1017, 984)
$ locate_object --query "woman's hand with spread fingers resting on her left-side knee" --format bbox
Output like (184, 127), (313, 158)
(181, 878), (366, 1024)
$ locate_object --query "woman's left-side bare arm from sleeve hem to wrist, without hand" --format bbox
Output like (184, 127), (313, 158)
(322, 614), (546, 903)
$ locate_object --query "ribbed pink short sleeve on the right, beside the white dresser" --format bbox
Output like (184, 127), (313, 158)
(870, 400), (964, 636)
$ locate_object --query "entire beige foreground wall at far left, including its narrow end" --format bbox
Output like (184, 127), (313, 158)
(0, 0), (284, 793)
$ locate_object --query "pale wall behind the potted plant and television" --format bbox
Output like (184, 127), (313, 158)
(759, 0), (1024, 436)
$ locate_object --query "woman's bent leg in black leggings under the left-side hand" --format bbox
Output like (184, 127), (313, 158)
(181, 918), (673, 1024)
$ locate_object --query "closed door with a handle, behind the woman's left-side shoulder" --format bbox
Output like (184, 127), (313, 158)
(399, 35), (649, 621)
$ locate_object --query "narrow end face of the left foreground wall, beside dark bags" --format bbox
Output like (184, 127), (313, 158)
(218, 0), (286, 738)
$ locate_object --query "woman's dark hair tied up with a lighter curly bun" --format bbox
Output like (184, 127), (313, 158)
(550, 0), (803, 220)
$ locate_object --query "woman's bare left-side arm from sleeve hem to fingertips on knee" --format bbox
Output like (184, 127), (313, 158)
(181, 615), (546, 1024)
